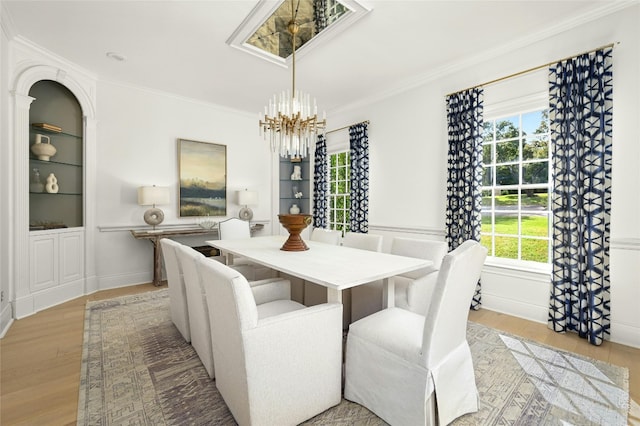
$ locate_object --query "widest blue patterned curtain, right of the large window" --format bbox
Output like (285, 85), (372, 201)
(548, 48), (613, 345)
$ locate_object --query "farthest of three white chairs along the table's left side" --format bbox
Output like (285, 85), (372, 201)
(160, 238), (191, 342)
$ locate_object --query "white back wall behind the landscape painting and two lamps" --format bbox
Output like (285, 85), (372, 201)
(96, 82), (272, 289)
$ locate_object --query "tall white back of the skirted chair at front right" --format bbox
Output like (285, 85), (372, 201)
(422, 240), (487, 369)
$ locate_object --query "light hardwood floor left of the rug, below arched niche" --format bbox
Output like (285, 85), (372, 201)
(0, 284), (166, 425)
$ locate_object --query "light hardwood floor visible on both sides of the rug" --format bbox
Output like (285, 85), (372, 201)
(0, 284), (640, 426)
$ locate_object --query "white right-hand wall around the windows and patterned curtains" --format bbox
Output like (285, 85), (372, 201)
(329, 4), (640, 347)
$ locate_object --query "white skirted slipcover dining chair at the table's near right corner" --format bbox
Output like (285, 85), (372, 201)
(344, 241), (487, 425)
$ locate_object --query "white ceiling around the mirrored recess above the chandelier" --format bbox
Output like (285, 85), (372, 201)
(1, 0), (629, 117)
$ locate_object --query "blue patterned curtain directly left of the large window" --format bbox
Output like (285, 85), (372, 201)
(445, 87), (483, 309)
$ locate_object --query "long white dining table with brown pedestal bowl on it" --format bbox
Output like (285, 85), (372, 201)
(206, 235), (433, 307)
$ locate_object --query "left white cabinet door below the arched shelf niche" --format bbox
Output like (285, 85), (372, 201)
(29, 234), (59, 292)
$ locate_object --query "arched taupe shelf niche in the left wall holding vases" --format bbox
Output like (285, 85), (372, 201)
(25, 80), (84, 230)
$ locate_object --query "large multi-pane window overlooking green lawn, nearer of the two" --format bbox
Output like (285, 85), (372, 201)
(481, 109), (551, 263)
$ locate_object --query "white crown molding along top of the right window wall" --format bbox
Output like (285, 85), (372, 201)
(327, 0), (639, 114)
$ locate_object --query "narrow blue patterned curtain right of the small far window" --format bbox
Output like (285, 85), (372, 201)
(349, 123), (369, 233)
